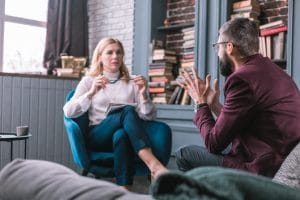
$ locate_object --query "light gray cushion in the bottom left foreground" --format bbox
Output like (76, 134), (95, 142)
(0, 159), (152, 200)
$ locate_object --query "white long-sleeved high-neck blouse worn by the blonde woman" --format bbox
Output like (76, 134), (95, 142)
(63, 73), (156, 125)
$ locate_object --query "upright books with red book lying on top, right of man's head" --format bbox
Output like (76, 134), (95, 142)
(259, 20), (288, 60)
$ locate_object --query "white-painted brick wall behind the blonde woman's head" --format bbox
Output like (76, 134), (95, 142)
(88, 0), (134, 69)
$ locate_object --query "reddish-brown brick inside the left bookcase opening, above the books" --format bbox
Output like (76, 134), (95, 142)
(166, 0), (195, 53)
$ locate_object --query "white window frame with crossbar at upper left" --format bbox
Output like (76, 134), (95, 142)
(0, 0), (47, 73)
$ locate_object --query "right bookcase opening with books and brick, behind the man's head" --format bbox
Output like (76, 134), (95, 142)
(230, 0), (288, 70)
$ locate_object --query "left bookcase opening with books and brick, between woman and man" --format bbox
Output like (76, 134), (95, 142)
(148, 0), (195, 105)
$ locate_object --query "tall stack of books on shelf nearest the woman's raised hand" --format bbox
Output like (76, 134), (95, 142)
(148, 48), (177, 103)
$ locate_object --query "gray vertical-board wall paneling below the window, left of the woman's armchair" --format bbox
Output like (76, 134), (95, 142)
(0, 75), (78, 170)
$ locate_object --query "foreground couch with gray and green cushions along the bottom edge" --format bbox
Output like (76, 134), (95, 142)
(0, 143), (300, 200)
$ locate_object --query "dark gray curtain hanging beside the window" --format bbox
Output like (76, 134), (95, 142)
(43, 0), (88, 74)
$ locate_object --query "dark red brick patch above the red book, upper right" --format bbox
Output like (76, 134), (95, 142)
(259, 0), (288, 24)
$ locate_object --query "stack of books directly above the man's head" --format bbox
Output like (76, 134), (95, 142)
(230, 0), (260, 24)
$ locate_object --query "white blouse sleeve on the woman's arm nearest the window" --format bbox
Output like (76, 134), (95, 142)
(63, 77), (93, 118)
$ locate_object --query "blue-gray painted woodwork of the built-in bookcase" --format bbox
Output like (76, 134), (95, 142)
(133, 0), (300, 153)
